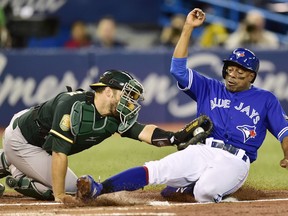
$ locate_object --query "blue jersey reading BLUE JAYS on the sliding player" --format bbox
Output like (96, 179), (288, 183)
(171, 58), (288, 162)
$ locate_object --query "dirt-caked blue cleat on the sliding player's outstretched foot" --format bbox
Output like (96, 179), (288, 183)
(77, 175), (103, 200)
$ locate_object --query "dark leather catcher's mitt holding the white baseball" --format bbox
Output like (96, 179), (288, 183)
(174, 115), (213, 150)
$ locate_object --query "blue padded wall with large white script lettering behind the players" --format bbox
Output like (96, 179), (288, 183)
(0, 46), (288, 126)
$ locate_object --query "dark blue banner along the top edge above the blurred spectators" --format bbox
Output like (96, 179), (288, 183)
(0, 0), (164, 26)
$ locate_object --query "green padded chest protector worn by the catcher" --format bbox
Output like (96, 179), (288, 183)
(70, 101), (118, 145)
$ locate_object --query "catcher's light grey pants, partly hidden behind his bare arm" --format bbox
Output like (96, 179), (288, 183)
(3, 120), (77, 199)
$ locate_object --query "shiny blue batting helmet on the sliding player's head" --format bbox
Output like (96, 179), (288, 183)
(222, 48), (259, 83)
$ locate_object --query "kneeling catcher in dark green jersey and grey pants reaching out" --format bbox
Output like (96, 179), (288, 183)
(0, 70), (200, 202)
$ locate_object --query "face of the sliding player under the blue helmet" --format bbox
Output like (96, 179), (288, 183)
(225, 66), (255, 92)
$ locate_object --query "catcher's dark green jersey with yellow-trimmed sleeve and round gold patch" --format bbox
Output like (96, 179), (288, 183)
(14, 91), (144, 155)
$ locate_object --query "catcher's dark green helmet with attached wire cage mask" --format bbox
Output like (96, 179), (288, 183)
(90, 70), (144, 128)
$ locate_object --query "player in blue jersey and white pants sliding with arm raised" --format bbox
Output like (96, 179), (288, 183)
(77, 8), (288, 202)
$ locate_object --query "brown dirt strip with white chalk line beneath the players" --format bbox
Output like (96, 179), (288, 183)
(0, 188), (288, 216)
